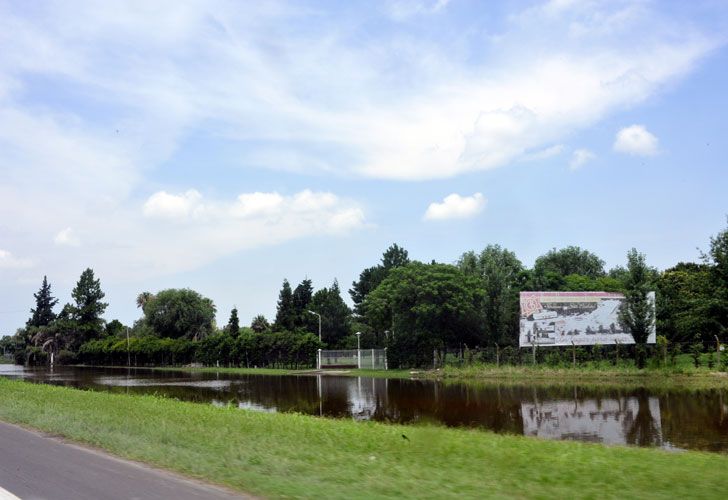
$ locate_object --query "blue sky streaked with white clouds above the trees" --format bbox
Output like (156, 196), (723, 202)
(0, 0), (728, 335)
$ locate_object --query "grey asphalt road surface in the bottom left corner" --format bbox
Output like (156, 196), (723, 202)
(0, 422), (250, 500)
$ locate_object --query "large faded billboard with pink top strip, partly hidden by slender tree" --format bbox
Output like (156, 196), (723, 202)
(518, 292), (655, 347)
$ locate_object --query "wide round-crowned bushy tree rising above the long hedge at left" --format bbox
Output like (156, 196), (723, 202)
(144, 288), (216, 340)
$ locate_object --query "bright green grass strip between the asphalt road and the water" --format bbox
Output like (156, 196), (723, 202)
(0, 379), (728, 498)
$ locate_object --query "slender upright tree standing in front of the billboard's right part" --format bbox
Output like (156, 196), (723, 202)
(619, 248), (655, 368)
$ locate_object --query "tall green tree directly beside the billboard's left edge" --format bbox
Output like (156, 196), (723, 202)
(458, 245), (524, 344)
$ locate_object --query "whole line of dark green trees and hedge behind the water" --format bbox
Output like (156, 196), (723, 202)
(3, 221), (728, 367)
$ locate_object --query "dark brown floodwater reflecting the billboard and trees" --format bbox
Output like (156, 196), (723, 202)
(0, 365), (728, 453)
